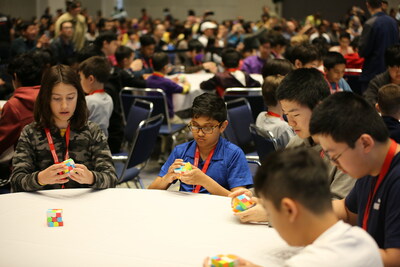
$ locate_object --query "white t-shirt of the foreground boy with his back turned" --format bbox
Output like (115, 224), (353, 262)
(284, 221), (383, 267)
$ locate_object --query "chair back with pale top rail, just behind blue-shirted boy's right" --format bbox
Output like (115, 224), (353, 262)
(224, 87), (266, 121)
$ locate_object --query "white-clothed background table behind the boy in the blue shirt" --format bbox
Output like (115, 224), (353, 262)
(170, 73), (263, 111)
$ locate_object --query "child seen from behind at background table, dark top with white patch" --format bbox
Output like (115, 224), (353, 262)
(200, 48), (261, 97)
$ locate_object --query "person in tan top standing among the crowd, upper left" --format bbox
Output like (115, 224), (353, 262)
(55, 0), (87, 51)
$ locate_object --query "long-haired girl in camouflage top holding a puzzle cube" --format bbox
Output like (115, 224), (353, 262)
(11, 65), (117, 192)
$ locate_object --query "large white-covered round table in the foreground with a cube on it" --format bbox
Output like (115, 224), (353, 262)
(0, 189), (293, 267)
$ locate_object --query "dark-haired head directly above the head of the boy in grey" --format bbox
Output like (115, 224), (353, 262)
(286, 44), (321, 69)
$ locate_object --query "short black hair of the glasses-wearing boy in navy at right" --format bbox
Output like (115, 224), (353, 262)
(310, 92), (389, 148)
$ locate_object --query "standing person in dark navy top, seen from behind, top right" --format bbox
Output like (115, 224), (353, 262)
(359, 0), (399, 92)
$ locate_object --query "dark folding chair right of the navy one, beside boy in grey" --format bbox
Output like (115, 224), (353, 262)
(249, 124), (279, 162)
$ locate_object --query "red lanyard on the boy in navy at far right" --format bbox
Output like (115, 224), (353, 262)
(362, 140), (397, 231)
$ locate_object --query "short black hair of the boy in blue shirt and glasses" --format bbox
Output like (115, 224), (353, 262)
(190, 93), (227, 122)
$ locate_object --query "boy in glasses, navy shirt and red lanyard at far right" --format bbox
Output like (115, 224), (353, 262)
(310, 92), (400, 266)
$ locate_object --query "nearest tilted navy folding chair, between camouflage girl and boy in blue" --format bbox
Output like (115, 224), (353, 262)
(115, 114), (164, 189)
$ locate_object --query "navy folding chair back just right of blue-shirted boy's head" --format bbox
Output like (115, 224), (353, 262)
(225, 98), (256, 155)
